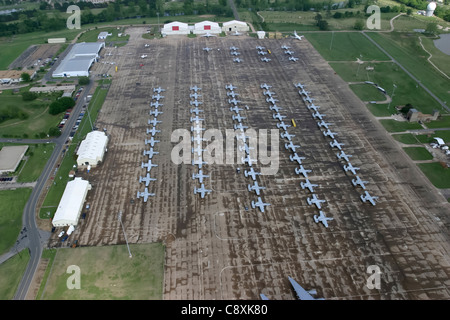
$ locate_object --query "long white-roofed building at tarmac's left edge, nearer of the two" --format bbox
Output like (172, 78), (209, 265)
(52, 178), (92, 227)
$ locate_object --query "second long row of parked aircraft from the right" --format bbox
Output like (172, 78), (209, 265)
(260, 83), (333, 227)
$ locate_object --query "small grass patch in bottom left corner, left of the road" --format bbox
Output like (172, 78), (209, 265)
(0, 250), (30, 300)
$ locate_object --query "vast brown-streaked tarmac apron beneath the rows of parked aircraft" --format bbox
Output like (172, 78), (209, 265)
(50, 27), (450, 300)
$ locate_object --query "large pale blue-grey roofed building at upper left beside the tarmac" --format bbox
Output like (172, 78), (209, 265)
(52, 42), (105, 78)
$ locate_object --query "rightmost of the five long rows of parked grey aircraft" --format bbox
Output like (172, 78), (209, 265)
(294, 83), (378, 205)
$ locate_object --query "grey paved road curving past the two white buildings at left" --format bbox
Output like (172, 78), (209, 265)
(8, 81), (94, 300)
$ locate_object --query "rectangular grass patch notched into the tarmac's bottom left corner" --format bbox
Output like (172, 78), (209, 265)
(37, 243), (165, 300)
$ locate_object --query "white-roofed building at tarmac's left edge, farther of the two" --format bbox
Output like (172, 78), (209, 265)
(77, 131), (108, 167)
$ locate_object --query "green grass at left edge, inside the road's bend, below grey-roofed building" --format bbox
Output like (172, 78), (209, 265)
(0, 188), (31, 255)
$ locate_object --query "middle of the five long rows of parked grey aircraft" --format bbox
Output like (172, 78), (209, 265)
(225, 84), (270, 212)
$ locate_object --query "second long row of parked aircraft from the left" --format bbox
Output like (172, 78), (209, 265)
(189, 85), (212, 199)
